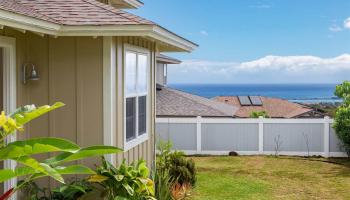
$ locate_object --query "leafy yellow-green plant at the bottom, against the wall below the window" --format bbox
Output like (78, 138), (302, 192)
(88, 157), (155, 200)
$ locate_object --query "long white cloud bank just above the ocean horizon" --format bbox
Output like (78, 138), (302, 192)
(169, 54), (350, 83)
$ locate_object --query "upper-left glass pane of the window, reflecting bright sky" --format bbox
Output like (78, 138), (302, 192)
(125, 52), (136, 95)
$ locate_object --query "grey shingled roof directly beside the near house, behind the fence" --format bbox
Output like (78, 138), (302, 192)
(156, 86), (237, 117)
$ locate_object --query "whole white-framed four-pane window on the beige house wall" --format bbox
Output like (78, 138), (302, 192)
(124, 45), (150, 150)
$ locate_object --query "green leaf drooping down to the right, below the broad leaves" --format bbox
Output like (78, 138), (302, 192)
(13, 156), (64, 183)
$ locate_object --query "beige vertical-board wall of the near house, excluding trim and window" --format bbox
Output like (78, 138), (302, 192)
(0, 28), (156, 188)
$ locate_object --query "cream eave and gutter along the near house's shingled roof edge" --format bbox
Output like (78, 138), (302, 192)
(0, 10), (198, 52)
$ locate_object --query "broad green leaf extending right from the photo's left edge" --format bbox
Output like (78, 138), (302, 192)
(0, 138), (80, 160)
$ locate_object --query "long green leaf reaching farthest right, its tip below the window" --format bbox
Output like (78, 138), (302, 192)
(45, 146), (122, 165)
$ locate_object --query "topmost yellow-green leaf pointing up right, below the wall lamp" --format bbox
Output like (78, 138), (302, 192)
(11, 102), (65, 126)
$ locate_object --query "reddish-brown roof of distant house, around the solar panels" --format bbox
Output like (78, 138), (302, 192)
(213, 96), (322, 118)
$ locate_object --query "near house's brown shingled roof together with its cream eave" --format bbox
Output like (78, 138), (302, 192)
(0, 0), (197, 51)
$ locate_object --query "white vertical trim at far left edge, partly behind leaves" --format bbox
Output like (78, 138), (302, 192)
(0, 36), (17, 199)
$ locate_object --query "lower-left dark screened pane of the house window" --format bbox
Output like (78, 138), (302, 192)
(125, 97), (136, 141)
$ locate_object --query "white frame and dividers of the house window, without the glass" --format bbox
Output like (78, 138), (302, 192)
(123, 44), (152, 151)
